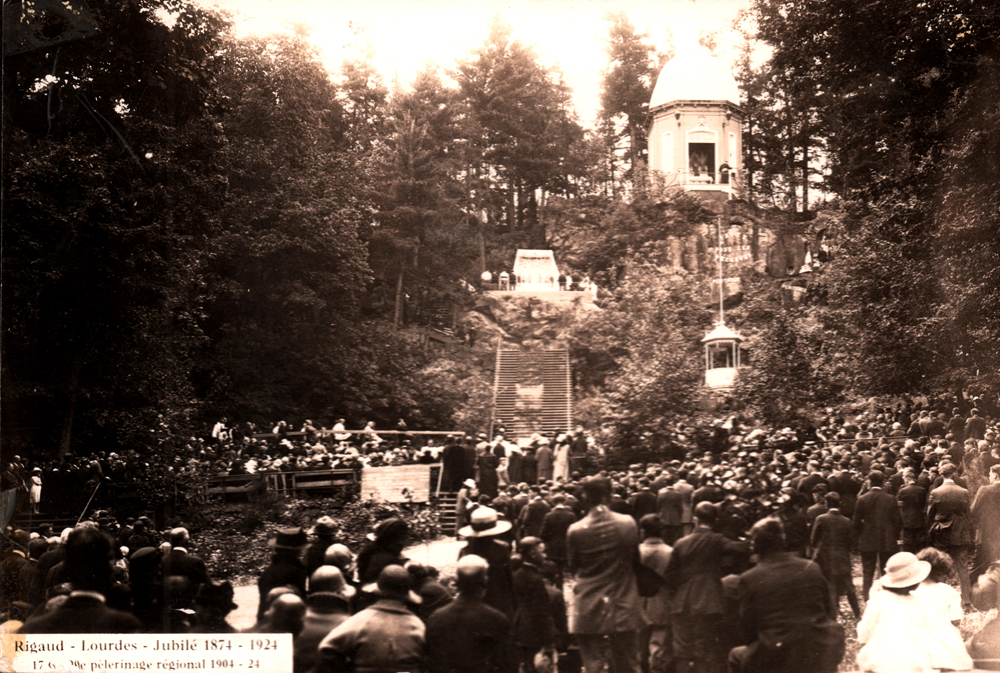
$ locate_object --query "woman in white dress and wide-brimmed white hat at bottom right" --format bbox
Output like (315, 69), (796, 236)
(858, 552), (933, 673)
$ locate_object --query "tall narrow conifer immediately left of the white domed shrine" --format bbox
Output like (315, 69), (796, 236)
(599, 12), (667, 189)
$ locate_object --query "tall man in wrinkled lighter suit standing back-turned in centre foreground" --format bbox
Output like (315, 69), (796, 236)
(566, 477), (644, 673)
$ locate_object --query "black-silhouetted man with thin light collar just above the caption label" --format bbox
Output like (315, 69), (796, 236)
(20, 528), (142, 633)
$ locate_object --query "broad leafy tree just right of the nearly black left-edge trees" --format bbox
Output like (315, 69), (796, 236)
(191, 35), (371, 422)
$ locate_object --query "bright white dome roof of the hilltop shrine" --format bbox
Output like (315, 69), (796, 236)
(649, 45), (740, 110)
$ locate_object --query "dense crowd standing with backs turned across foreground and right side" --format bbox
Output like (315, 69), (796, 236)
(0, 400), (1000, 673)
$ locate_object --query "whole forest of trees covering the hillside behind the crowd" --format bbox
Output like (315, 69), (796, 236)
(0, 0), (1000, 455)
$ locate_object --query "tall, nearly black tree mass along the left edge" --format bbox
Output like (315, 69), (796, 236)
(2, 0), (225, 454)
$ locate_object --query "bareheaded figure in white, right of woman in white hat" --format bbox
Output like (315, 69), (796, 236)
(915, 547), (973, 671)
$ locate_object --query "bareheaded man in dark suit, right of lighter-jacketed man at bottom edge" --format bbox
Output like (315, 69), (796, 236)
(427, 555), (517, 673)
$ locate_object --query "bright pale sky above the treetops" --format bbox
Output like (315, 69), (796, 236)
(199, 0), (749, 126)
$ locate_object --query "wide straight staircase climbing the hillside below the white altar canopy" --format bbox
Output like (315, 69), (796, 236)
(493, 349), (573, 440)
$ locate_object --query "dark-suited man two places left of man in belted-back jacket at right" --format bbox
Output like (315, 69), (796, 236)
(854, 470), (903, 600)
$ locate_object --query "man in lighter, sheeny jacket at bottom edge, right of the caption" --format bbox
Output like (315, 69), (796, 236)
(317, 565), (426, 673)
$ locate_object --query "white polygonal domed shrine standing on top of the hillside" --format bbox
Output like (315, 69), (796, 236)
(649, 45), (743, 200)
